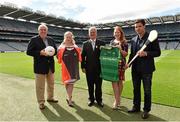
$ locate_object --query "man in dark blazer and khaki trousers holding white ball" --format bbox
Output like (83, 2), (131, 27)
(26, 24), (58, 109)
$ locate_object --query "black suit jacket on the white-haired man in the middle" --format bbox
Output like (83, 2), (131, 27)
(81, 40), (105, 75)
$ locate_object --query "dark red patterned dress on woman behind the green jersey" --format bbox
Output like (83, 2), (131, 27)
(110, 40), (128, 81)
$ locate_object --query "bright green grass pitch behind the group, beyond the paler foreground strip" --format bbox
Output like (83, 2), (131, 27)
(0, 50), (180, 107)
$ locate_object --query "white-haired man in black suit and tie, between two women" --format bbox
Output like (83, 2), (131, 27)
(81, 27), (104, 107)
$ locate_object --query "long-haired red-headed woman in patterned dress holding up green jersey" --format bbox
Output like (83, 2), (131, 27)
(110, 26), (128, 109)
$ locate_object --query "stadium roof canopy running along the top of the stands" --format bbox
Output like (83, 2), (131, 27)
(0, 3), (180, 29)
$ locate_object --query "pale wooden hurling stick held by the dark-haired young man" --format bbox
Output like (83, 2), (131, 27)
(128, 30), (158, 66)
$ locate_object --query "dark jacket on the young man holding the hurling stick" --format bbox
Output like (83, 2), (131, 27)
(128, 32), (161, 73)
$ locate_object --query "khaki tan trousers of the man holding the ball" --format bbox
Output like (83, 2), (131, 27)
(35, 70), (54, 104)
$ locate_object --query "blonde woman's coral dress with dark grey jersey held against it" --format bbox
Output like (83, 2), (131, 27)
(57, 46), (81, 84)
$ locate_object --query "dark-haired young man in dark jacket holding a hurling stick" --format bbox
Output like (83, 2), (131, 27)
(128, 19), (161, 119)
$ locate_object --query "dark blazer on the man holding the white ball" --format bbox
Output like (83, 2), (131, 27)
(26, 36), (57, 74)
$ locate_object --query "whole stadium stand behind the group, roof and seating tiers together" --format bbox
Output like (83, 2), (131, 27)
(0, 4), (180, 52)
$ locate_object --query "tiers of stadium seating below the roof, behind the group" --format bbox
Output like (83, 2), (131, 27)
(0, 17), (180, 52)
